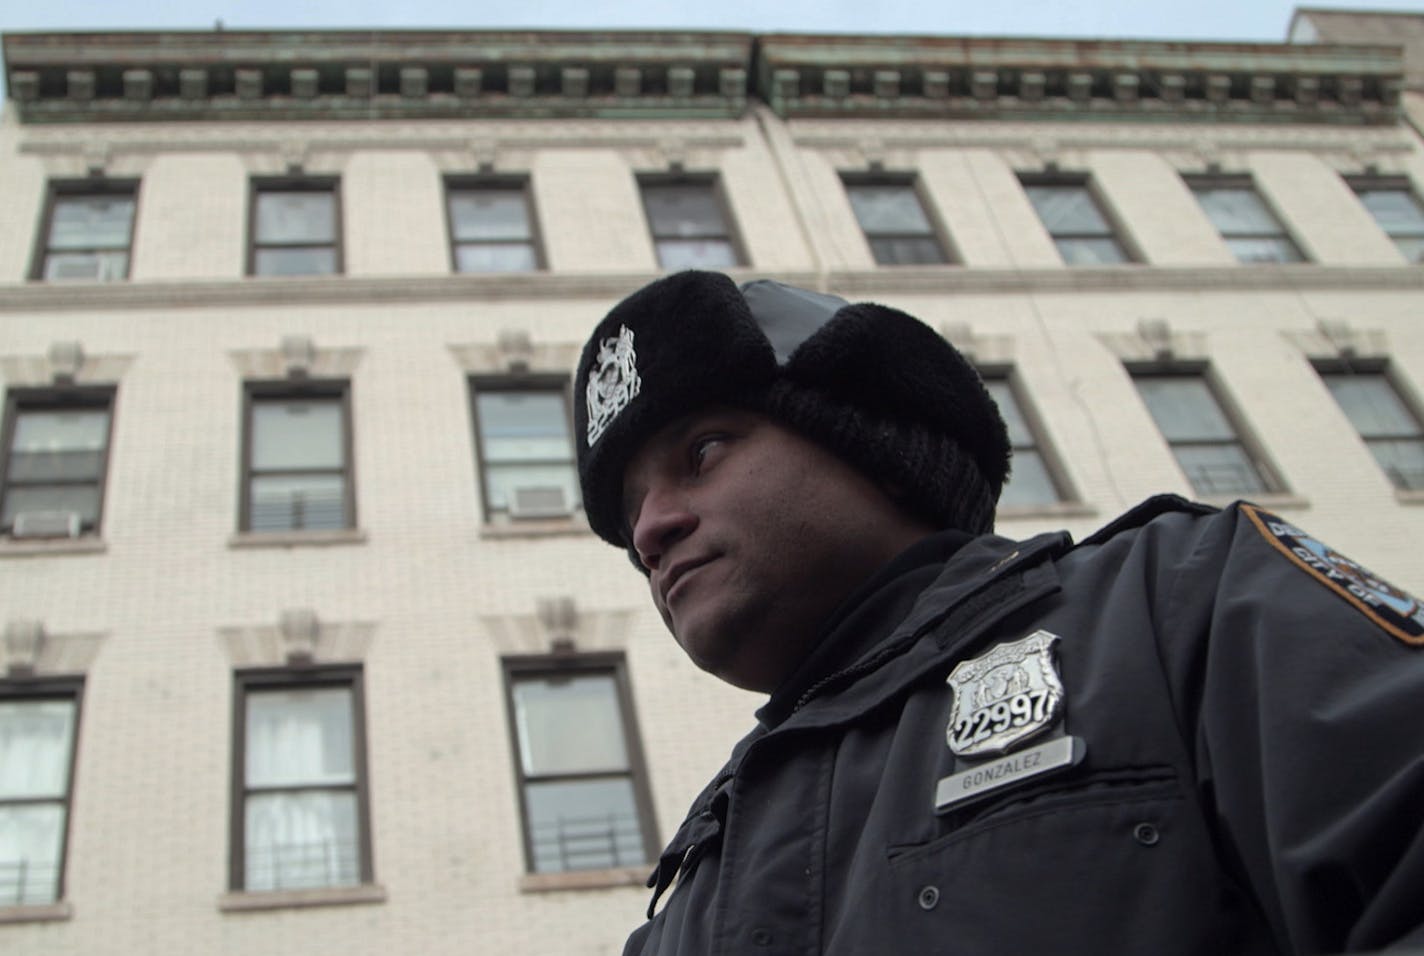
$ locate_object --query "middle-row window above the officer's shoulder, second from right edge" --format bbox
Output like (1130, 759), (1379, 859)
(1134, 373), (1277, 494)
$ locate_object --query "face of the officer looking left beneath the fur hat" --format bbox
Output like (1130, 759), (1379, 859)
(624, 407), (931, 691)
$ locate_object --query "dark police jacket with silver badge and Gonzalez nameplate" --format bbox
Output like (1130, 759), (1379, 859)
(625, 497), (1424, 956)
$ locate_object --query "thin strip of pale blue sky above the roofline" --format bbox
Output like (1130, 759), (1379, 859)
(0, 0), (1424, 41)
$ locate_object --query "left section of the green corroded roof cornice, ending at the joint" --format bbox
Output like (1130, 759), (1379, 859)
(4, 31), (752, 123)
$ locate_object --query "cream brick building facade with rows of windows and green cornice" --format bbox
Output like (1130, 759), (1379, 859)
(0, 16), (1424, 956)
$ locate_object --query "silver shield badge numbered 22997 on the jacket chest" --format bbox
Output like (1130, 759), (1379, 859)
(946, 630), (1064, 757)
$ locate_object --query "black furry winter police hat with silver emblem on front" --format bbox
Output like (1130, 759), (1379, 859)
(574, 272), (1010, 558)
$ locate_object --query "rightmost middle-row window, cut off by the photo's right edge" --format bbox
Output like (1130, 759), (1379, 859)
(1319, 363), (1424, 492)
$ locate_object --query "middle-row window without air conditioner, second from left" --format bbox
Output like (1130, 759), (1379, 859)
(242, 382), (356, 531)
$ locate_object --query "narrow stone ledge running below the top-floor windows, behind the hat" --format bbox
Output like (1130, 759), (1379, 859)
(0, 264), (1424, 313)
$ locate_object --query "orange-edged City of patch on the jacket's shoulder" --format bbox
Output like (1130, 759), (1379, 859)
(1240, 504), (1424, 647)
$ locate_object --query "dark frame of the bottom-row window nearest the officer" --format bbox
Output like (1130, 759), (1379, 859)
(500, 651), (662, 875)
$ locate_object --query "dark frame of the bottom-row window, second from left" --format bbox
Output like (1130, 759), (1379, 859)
(228, 664), (376, 893)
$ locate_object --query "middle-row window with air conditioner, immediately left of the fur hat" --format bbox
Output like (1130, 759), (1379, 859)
(471, 380), (578, 519)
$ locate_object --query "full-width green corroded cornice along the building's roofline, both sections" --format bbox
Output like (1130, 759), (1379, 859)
(4, 30), (1404, 124)
